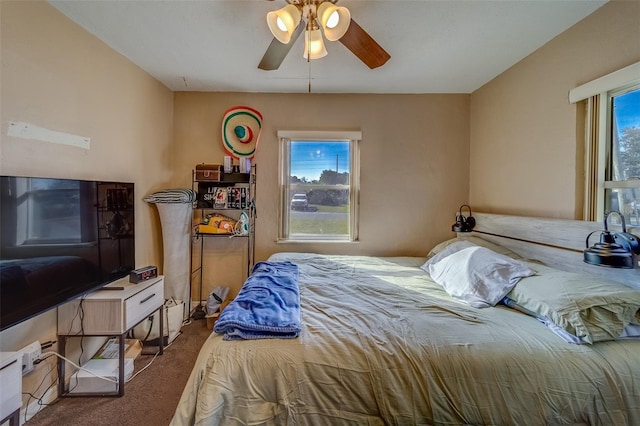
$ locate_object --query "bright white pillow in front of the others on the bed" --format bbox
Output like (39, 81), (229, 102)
(428, 247), (535, 308)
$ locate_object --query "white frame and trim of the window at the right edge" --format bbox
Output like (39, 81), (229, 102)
(569, 62), (640, 221)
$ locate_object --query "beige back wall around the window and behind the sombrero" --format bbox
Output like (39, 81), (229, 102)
(174, 92), (469, 294)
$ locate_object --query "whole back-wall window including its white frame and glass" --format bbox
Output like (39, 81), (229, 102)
(278, 131), (360, 242)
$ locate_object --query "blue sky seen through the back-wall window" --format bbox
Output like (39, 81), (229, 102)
(291, 141), (349, 182)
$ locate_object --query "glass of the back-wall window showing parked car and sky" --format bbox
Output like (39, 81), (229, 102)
(287, 140), (351, 240)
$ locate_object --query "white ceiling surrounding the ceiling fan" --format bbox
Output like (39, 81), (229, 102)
(50, 0), (606, 93)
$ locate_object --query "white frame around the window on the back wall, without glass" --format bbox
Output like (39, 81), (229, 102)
(277, 130), (362, 243)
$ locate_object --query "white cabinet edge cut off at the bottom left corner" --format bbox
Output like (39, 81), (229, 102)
(0, 352), (22, 426)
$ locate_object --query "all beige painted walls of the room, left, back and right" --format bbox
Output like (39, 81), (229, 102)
(7, 1), (640, 416)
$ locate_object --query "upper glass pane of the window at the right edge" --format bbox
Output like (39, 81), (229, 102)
(611, 89), (640, 181)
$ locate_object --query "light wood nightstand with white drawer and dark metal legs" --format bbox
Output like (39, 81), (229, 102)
(58, 276), (164, 396)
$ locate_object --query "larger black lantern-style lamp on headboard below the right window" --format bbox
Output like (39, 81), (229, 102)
(584, 211), (640, 269)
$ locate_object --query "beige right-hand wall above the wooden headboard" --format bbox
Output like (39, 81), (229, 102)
(470, 1), (640, 219)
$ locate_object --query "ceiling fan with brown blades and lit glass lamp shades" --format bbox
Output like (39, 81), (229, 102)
(258, 0), (391, 71)
